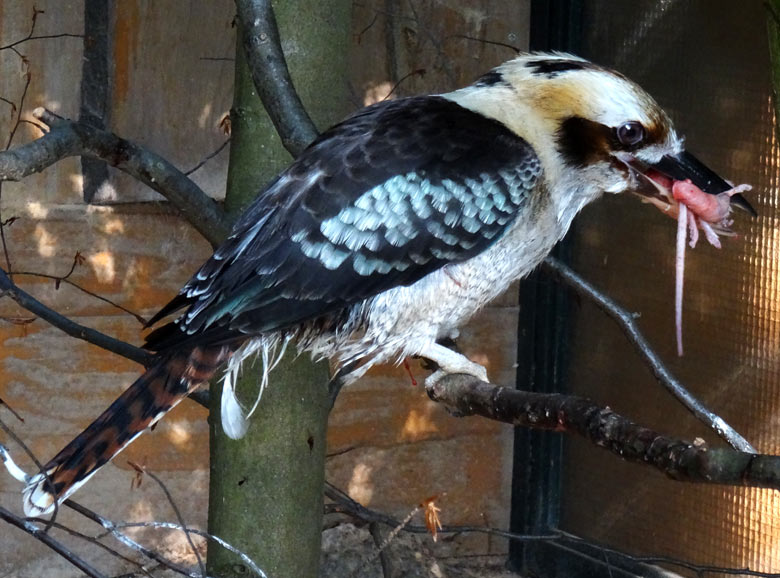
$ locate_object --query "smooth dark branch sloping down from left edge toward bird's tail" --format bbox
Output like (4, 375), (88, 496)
(0, 269), (153, 366)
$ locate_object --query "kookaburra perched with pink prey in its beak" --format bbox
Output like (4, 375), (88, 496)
(16, 53), (749, 515)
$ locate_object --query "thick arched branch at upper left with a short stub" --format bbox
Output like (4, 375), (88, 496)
(0, 108), (230, 245)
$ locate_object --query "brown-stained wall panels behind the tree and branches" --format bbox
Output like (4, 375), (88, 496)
(0, 0), (528, 576)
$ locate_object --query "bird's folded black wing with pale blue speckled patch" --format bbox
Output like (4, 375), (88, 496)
(143, 96), (540, 349)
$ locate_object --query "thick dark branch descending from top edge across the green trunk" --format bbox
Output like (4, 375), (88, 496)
(236, 0), (317, 157)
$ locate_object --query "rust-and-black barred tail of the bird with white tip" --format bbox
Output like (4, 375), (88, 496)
(23, 345), (233, 516)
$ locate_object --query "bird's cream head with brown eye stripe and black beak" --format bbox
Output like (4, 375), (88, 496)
(448, 53), (754, 218)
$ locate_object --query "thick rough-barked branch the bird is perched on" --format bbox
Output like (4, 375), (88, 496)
(426, 374), (780, 490)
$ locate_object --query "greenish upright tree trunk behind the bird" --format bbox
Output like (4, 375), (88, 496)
(208, 0), (351, 578)
